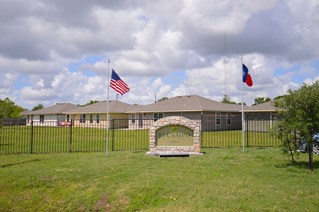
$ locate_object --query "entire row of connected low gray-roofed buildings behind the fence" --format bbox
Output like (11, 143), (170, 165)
(24, 95), (276, 131)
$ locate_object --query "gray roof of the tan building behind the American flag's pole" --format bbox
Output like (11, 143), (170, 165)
(65, 100), (132, 114)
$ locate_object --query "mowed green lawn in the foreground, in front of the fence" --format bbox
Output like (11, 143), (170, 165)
(0, 148), (319, 211)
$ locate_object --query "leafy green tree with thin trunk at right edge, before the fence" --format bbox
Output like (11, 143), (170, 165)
(275, 81), (319, 170)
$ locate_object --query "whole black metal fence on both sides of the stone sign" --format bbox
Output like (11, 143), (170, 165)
(0, 115), (281, 154)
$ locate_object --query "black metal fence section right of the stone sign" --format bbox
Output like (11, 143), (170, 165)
(201, 113), (281, 148)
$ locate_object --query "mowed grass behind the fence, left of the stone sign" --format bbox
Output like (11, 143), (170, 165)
(0, 126), (149, 154)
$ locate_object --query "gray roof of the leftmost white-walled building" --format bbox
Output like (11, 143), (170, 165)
(23, 103), (79, 115)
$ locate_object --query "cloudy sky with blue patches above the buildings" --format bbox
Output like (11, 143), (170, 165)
(0, 0), (319, 110)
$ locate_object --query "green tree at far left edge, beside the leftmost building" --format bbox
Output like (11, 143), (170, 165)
(0, 98), (24, 119)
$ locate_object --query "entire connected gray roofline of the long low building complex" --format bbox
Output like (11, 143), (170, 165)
(23, 95), (276, 115)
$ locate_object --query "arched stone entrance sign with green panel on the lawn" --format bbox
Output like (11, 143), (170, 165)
(146, 116), (202, 156)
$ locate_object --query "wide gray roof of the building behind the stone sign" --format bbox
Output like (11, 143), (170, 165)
(127, 95), (246, 113)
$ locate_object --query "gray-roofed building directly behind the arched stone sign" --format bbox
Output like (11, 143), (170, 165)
(126, 95), (241, 130)
